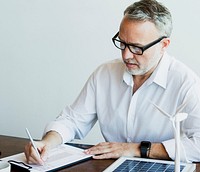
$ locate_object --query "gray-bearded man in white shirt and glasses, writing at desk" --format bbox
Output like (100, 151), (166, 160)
(25, 0), (200, 164)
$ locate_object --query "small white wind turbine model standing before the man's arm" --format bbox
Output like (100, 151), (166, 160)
(151, 102), (188, 172)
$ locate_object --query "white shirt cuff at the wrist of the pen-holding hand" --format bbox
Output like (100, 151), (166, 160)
(44, 121), (73, 143)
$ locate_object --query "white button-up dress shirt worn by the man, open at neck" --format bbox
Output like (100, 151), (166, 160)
(45, 53), (200, 162)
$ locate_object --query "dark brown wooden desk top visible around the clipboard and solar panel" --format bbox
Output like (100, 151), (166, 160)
(0, 135), (200, 172)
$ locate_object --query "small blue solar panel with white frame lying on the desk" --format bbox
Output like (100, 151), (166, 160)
(104, 157), (196, 172)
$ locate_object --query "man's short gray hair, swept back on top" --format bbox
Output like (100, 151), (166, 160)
(124, 0), (173, 37)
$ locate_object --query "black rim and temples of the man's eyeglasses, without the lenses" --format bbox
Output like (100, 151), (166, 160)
(112, 32), (167, 55)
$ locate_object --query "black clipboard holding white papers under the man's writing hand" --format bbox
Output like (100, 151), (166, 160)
(1, 144), (92, 172)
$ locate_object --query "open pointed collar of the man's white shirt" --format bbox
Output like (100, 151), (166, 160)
(123, 53), (170, 89)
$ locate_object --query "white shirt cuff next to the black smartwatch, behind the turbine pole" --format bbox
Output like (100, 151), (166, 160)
(162, 139), (189, 163)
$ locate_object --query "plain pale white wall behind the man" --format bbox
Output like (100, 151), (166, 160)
(0, 0), (200, 143)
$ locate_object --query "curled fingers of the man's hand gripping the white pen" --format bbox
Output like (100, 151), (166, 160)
(24, 142), (44, 165)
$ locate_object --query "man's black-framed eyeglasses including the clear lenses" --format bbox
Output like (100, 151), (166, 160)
(112, 32), (167, 55)
